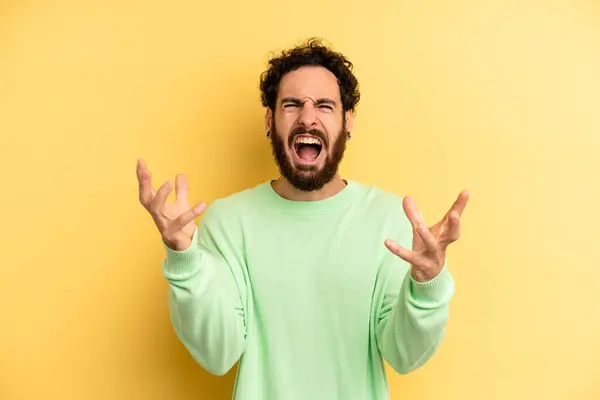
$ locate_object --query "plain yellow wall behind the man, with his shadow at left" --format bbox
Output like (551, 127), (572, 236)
(0, 0), (600, 400)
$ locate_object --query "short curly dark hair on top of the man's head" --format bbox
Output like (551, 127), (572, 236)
(260, 38), (360, 112)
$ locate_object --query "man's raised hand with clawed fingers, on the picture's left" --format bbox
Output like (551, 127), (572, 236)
(137, 160), (206, 251)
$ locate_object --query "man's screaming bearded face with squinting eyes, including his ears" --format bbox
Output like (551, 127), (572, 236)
(267, 67), (352, 191)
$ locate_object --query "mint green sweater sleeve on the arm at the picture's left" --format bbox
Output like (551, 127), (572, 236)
(163, 203), (246, 375)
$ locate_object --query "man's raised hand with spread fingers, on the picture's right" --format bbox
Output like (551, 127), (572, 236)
(385, 191), (469, 282)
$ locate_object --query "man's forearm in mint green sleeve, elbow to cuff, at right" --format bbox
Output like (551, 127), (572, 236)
(378, 267), (454, 374)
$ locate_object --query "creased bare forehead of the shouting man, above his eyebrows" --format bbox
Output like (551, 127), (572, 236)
(278, 66), (340, 101)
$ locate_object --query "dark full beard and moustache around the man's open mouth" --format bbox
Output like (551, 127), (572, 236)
(271, 118), (347, 192)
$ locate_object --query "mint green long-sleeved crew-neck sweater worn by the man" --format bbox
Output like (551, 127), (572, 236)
(163, 181), (454, 400)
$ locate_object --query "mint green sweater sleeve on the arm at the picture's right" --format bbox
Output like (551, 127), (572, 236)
(376, 209), (454, 374)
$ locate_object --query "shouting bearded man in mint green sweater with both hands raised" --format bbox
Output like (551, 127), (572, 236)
(137, 40), (468, 400)
